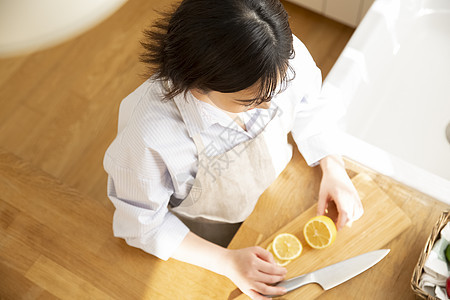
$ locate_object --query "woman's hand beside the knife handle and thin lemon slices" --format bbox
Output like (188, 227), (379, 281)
(223, 246), (287, 300)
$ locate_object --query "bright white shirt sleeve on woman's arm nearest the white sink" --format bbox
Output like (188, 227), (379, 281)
(291, 36), (344, 166)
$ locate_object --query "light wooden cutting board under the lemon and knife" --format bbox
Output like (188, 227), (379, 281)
(234, 173), (411, 299)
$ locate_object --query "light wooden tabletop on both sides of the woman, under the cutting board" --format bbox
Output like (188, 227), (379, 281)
(0, 141), (447, 299)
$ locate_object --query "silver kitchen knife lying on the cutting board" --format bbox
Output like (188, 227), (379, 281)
(264, 249), (390, 298)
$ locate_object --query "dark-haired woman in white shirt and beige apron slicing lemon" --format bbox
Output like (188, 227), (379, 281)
(104, 0), (363, 299)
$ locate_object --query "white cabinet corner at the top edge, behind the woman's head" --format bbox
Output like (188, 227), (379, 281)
(288, 0), (374, 27)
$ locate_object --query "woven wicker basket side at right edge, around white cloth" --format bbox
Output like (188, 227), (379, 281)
(411, 211), (450, 300)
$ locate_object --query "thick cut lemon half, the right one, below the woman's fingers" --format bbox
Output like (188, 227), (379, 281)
(303, 216), (337, 249)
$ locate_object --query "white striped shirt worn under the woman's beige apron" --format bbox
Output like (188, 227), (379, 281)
(103, 37), (342, 260)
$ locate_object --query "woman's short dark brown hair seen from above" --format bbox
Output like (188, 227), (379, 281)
(140, 0), (294, 104)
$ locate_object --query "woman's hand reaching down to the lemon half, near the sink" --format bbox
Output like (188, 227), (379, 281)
(317, 155), (364, 230)
